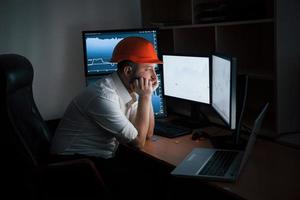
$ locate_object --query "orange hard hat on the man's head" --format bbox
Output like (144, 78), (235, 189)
(111, 37), (162, 64)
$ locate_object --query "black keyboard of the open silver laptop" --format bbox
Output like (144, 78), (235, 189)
(199, 151), (238, 176)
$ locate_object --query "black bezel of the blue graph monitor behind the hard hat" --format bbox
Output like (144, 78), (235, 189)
(81, 27), (159, 77)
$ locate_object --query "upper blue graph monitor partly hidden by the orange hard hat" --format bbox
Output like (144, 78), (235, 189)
(82, 29), (157, 76)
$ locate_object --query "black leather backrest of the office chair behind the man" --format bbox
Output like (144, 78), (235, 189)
(0, 54), (51, 167)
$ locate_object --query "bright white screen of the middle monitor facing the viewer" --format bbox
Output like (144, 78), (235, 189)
(163, 55), (210, 104)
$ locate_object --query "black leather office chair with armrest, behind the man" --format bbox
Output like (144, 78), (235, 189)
(0, 54), (108, 199)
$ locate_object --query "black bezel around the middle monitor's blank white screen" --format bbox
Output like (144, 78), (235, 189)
(161, 54), (212, 105)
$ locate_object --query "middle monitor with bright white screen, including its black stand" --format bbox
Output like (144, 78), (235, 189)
(162, 55), (211, 128)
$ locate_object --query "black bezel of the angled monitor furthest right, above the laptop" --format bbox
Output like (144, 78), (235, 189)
(210, 53), (237, 130)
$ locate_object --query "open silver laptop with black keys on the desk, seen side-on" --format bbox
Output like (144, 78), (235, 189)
(171, 103), (269, 182)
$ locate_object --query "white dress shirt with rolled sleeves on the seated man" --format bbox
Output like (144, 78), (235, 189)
(51, 72), (138, 158)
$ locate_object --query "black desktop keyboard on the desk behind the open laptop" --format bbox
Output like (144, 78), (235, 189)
(154, 121), (192, 138)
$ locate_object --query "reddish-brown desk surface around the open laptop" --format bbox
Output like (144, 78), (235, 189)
(142, 128), (300, 200)
